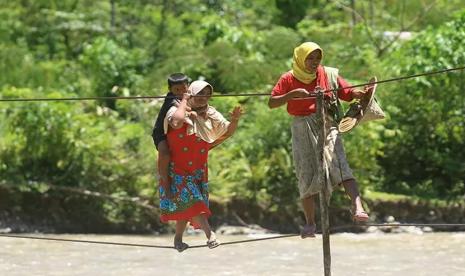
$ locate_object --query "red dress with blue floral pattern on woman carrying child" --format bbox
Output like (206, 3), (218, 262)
(159, 123), (211, 228)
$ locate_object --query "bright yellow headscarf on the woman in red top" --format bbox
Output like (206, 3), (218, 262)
(291, 42), (323, 84)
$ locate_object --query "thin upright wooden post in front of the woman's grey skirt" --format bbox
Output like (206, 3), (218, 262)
(316, 88), (331, 276)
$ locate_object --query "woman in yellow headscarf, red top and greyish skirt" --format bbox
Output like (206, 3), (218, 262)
(268, 42), (368, 238)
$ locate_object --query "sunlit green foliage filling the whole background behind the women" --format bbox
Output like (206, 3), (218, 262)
(0, 0), (465, 229)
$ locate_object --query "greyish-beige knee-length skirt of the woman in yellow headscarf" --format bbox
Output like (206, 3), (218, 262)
(292, 114), (354, 198)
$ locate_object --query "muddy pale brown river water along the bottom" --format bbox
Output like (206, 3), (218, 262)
(0, 232), (465, 276)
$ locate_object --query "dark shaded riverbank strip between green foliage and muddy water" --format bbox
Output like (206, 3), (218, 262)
(0, 187), (465, 234)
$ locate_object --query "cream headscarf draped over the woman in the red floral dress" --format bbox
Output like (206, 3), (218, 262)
(165, 80), (229, 143)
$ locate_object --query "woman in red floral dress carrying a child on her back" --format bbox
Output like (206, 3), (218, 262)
(159, 78), (242, 252)
